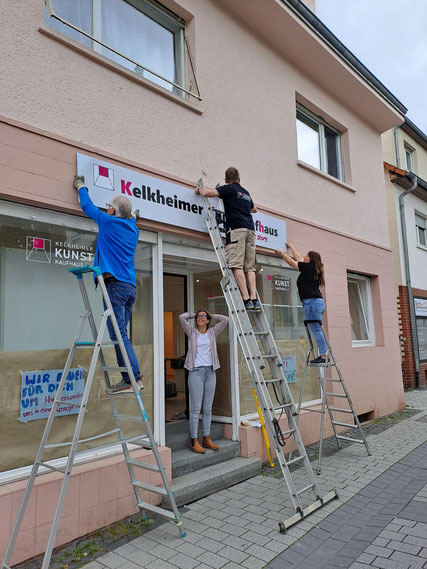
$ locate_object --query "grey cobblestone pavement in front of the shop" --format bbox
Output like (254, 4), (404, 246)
(84, 390), (427, 569)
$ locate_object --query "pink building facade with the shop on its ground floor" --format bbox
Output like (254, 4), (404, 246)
(0, 0), (405, 563)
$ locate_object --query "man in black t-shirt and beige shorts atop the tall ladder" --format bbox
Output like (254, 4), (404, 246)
(196, 167), (261, 310)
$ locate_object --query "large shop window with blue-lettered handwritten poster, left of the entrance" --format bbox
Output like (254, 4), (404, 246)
(0, 209), (153, 471)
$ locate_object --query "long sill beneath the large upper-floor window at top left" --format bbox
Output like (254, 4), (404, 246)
(39, 25), (203, 115)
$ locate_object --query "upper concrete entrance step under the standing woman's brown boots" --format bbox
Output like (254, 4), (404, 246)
(172, 439), (240, 480)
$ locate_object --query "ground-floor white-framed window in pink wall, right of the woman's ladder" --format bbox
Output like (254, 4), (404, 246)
(347, 273), (375, 347)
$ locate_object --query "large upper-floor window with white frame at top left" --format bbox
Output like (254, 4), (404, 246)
(45, 0), (185, 96)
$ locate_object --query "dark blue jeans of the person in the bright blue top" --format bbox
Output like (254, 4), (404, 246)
(104, 281), (141, 383)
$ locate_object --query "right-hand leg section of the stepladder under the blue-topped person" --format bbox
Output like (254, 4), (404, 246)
(79, 273), (185, 537)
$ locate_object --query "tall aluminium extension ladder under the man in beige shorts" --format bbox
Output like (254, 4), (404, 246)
(199, 196), (338, 533)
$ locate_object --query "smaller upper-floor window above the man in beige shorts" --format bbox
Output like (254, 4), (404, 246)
(297, 105), (343, 180)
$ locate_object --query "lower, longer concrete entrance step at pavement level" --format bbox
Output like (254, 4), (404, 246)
(162, 457), (261, 508)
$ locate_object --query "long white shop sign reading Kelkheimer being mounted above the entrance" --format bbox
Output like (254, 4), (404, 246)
(77, 154), (286, 249)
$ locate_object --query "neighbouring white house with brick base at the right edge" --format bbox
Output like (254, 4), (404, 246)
(382, 119), (427, 389)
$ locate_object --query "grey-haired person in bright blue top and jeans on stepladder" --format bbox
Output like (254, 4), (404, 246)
(73, 176), (144, 394)
